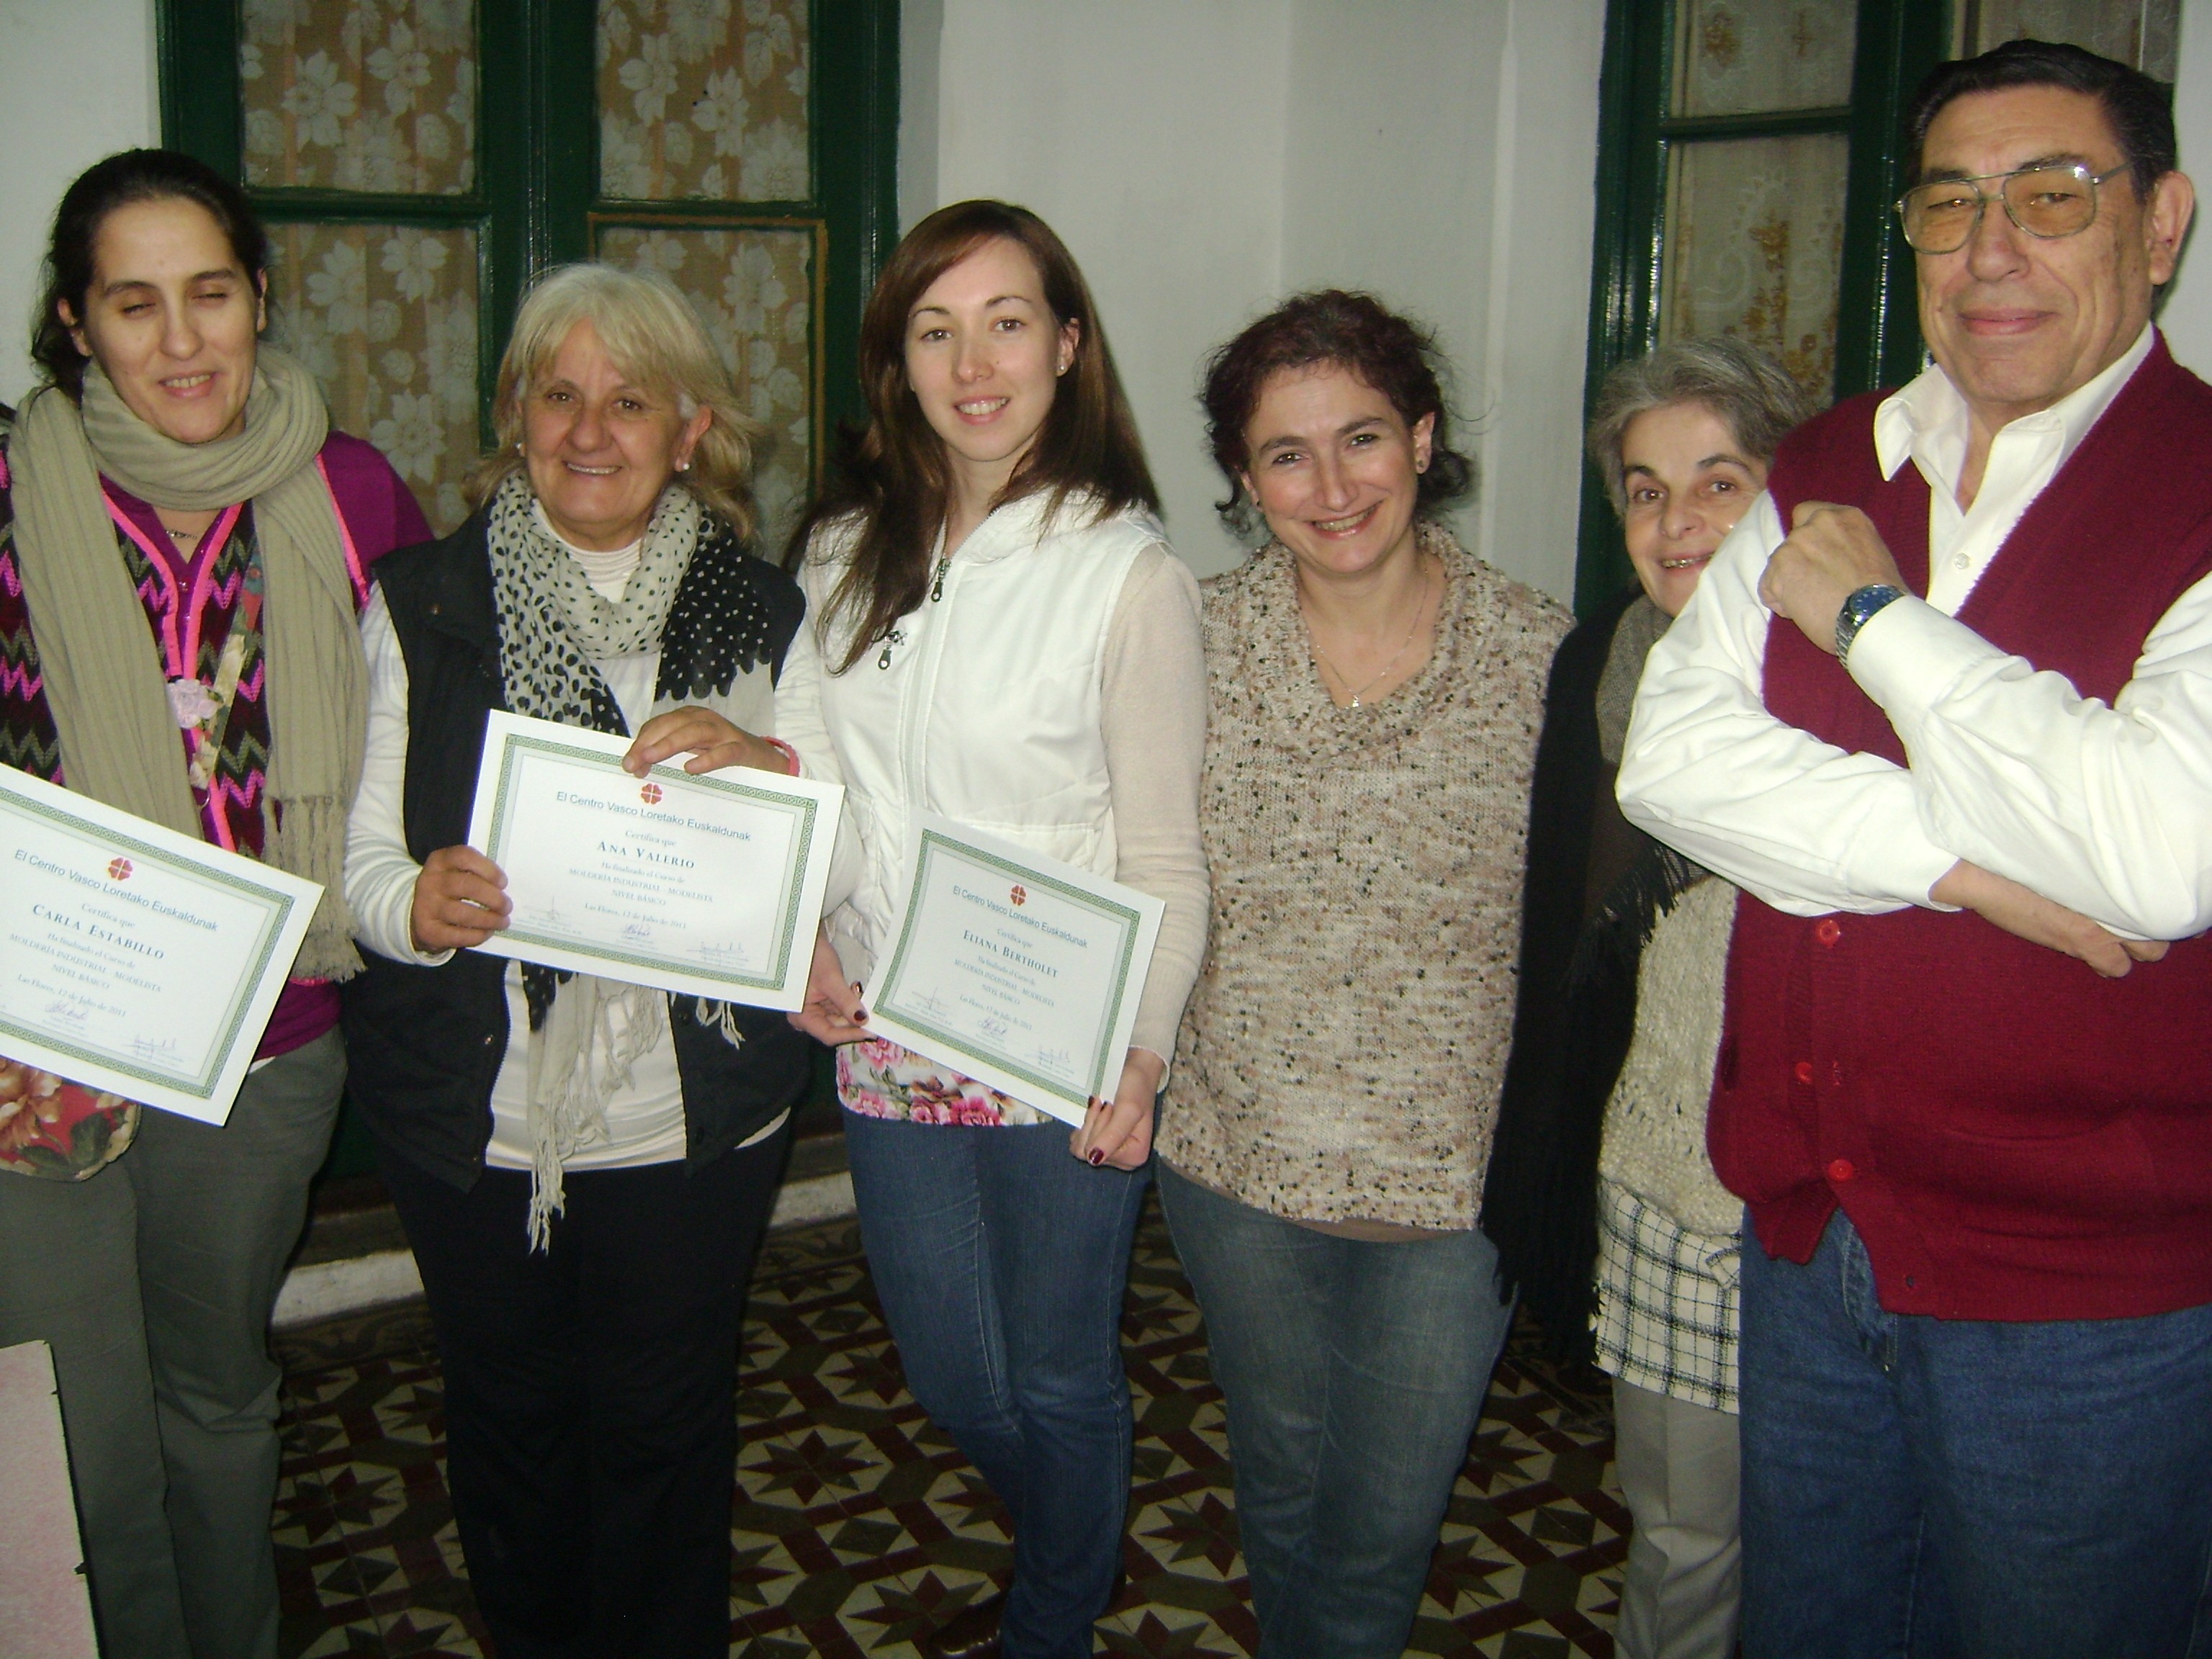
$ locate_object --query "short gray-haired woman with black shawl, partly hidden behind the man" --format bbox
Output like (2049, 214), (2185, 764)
(1482, 338), (1814, 1659)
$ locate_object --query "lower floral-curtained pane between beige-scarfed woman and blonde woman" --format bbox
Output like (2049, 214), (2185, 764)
(270, 225), (480, 535)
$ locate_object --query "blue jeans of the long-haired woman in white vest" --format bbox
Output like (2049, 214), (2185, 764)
(845, 1112), (1146, 1659)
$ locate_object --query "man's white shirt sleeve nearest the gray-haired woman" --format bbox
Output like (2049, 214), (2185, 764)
(1619, 493), (1960, 916)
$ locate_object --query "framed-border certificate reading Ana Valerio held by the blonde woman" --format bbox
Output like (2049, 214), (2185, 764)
(469, 714), (845, 1009)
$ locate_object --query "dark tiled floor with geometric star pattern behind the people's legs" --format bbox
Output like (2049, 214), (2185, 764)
(276, 1210), (1628, 1659)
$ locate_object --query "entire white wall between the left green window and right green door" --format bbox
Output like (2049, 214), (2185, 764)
(900, 0), (1604, 595)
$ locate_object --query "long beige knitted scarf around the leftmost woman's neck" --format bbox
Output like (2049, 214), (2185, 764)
(9, 347), (367, 980)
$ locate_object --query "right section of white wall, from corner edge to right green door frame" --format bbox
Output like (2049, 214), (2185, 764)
(1281, 0), (1604, 597)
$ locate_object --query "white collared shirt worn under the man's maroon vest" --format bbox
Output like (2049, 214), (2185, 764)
(1619, 328), (2212, 938)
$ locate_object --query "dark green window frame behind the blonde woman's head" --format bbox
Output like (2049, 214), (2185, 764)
(157, 0), (898, 519)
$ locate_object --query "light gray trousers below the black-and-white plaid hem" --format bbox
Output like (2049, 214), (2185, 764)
(1612, 1378), (1743, 1659)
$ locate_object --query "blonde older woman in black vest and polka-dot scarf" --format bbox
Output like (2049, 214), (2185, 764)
(345, 266), (809, 1659)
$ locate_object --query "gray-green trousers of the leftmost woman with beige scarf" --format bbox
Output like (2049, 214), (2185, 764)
(0, 1031), (345, 1659)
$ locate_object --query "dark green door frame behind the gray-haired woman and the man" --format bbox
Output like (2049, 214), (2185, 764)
(1575, 0), (1951, 615)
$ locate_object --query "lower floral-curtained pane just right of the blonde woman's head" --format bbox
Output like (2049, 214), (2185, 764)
(600, 228), (814, 555)
